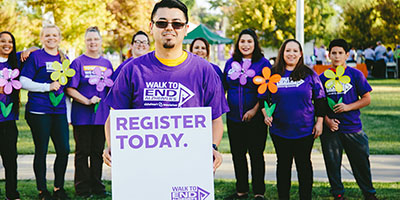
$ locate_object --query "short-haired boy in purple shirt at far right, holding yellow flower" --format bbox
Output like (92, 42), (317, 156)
(320, 39), (377, 200)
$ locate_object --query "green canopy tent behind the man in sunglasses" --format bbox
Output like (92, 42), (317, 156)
(183, 24), (233, 45)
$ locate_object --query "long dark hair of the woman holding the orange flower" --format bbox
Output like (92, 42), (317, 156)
(272, 39), (313, 81)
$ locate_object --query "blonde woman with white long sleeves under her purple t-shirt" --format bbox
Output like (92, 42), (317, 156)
(20, 25), (70, 199)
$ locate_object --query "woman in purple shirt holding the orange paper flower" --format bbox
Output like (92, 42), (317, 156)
(260, 39), (325, 200)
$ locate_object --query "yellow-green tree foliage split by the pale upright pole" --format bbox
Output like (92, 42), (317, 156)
(210, 0), (335, 47)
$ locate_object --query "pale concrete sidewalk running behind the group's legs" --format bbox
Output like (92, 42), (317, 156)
(0, 153), (400, 182)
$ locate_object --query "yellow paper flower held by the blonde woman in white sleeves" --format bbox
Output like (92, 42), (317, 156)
(50, 59), (75, 85)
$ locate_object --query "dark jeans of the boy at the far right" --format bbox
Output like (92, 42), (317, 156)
(321, 127), (376, 196)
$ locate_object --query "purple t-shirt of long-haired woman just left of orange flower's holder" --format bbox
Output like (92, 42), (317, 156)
(224, 57), (271, 122)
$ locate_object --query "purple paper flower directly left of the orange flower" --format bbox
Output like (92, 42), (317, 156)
(228, 60), (256, 85)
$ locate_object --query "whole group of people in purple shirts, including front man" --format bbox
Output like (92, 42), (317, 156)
(0, 0), (377, 200)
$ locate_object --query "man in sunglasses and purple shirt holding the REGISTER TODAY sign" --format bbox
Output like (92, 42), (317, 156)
(103, 0), (229, 170)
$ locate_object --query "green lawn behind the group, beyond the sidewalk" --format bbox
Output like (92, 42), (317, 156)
(17, 79), (400, 154)
